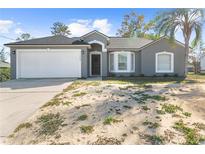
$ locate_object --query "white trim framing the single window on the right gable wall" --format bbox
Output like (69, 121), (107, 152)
(155, 51), (174, 73)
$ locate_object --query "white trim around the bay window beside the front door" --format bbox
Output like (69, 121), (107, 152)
(109, 51), (135, 73)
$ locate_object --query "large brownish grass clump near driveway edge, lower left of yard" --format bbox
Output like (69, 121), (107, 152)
(36, 113), (66, 135)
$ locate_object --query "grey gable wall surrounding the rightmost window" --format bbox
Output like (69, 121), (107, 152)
(141, 39), (185, 76)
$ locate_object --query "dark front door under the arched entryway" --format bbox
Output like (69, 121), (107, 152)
(91, 54), (101, 76)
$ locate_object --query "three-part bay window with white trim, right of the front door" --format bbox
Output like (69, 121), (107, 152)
(109, 51), (135, 72)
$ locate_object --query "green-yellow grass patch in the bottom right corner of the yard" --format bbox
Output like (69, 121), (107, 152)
(173, 120), (203, 145)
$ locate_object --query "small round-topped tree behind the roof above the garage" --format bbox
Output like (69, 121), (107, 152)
(51, 22), (71, 36)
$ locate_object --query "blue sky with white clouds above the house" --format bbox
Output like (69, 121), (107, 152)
(0, 8), (205, 61)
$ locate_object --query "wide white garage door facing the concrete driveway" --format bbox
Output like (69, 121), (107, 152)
(17, 49), (81, 78)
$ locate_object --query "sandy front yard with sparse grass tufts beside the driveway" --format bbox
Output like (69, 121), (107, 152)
(6, 81), (205, 145)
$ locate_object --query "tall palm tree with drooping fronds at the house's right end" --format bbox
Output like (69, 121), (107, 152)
(156, 9), (204, 76)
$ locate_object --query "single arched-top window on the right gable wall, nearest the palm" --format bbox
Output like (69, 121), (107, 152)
(156, 52), (174, 73)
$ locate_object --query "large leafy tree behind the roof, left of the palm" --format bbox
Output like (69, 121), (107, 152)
(117, 12), (158, 39)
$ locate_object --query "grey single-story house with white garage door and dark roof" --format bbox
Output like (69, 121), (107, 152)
(5, 31), (185, 79)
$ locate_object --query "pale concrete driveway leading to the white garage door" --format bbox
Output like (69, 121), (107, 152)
(0, 79), (74, 143)
